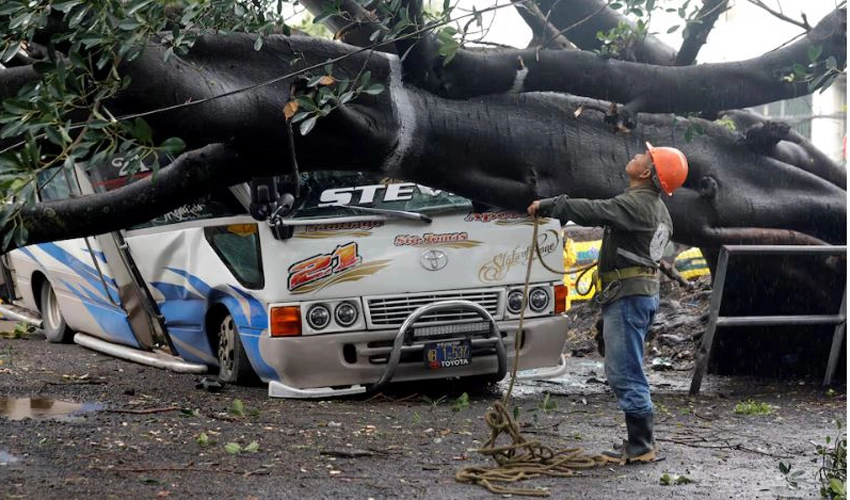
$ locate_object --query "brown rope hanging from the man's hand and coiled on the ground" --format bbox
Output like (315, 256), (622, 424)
(455, 216), (604, 497)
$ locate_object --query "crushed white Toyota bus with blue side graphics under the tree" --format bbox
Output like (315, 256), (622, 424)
(2, 161), (567, 398)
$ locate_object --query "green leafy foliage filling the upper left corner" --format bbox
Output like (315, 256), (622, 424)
(0, 0), (288, 247)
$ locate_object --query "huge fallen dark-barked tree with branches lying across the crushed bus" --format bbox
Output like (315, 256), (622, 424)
(0, 0), (846, 256)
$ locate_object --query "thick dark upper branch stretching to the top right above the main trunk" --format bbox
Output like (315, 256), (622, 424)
(396, 9), (846, 113)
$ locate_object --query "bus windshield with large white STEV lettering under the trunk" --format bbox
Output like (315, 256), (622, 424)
(292, 171), (472, 218)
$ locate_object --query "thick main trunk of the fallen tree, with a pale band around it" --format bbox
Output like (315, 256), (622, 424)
(4, 35), (846, 254)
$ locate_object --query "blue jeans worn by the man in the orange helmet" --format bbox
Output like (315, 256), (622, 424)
(602, 295), (658, 417)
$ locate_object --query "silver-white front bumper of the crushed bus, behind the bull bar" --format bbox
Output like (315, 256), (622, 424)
(260, 300), (568, 398)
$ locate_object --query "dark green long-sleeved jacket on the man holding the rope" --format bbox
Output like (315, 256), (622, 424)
(539, 186), (673, 300)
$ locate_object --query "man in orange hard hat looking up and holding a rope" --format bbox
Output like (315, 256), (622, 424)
(528, 143), (688, 463)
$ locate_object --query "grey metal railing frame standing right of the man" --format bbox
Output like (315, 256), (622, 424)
(690, 245), (847, 396)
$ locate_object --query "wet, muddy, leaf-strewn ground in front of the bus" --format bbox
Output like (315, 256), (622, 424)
(0, 324), (846, 500)
